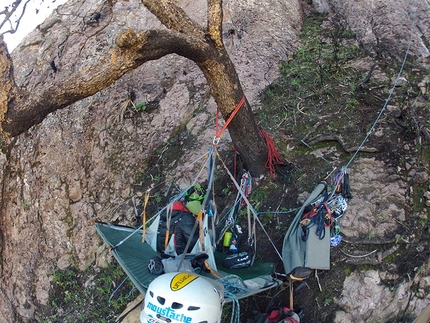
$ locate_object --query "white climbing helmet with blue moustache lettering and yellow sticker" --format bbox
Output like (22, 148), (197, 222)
(140, 272), (224, 323)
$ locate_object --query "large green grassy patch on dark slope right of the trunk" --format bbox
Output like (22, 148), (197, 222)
(259, 15), (364, 136)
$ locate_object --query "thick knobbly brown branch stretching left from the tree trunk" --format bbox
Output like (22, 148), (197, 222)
(0, 29), (215, 137)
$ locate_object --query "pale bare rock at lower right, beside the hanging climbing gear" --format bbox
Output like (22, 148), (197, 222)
(334, 158), (430, 323)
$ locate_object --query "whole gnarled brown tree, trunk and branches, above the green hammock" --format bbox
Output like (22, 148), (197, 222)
(0, 0), (267, 175)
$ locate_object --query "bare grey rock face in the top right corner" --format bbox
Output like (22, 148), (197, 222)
(312, 0), (430, 62)
